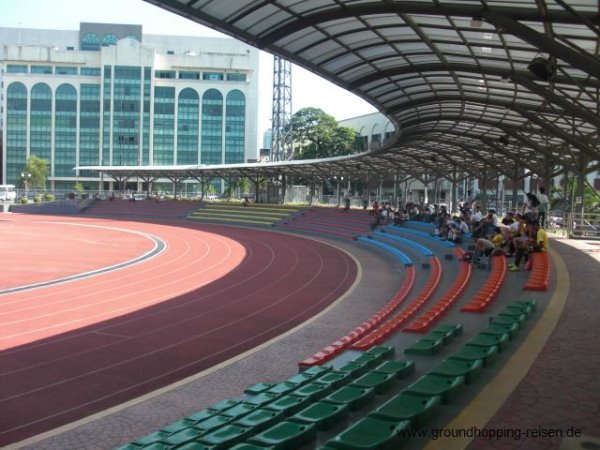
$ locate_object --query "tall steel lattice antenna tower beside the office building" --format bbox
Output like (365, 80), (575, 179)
(269, 55), (294, 161)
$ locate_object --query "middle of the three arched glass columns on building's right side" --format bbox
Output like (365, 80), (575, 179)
(200, 89), (223, 164)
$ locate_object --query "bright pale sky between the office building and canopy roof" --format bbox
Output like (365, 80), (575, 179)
(0, 0), (376, 137)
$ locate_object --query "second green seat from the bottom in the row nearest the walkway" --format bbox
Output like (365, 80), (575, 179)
(369, 391), (442, 428)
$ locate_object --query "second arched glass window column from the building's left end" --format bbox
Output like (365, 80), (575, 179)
(29, 83), (52, 161)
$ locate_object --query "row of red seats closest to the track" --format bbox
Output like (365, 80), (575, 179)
(298, 266), (415, 370)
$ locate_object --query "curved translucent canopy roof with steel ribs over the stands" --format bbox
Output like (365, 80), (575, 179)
(106, 0), (600, 183)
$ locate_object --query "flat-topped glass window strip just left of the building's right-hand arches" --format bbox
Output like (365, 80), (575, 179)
(153, 86), (175, 165)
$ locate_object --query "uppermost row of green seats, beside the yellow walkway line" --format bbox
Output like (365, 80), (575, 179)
(318, 301), (535, 450)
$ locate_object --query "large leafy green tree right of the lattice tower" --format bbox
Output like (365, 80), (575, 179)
(291, 108), (358, 159)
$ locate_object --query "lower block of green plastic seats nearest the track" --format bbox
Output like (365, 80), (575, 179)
(118, 346), (414, 450)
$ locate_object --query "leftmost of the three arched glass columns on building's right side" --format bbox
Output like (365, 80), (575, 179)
(176, 88), (200, 164)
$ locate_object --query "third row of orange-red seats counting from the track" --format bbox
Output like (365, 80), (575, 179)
(402, 248), (473, 333)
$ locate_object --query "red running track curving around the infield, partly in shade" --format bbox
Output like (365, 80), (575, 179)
(0, 215), (357, 445)
